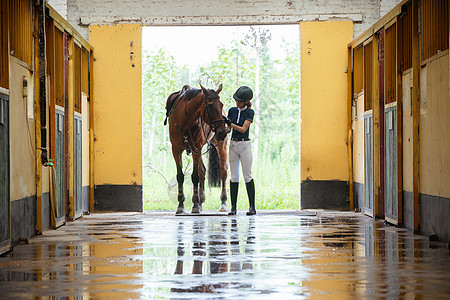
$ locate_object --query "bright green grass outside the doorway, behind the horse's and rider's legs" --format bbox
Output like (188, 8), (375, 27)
(144, 147), (300, 211)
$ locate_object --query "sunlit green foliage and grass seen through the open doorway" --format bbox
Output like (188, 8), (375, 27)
(143, 30), (300, 210)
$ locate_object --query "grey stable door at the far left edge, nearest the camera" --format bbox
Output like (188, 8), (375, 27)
(0, 94), (11, 254)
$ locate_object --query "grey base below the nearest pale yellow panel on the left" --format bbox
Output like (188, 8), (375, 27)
(11, 195), (37, 245)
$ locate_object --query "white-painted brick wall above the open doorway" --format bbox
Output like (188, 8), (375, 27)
(67, 0), (390, 39)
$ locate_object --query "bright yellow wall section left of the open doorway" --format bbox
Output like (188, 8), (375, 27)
(89, 24), (142, 185)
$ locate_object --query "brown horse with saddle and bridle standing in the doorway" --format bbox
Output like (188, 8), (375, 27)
(165, 85), (229, 214)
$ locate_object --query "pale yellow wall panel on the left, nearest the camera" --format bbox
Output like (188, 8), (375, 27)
(9, 57), (36, 201)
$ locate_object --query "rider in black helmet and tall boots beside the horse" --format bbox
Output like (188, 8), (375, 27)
(227, 86), (256, 216)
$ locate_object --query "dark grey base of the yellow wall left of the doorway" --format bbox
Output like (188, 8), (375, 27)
(94, 184), (143, 212)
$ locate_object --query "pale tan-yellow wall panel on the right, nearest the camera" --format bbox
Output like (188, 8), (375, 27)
(419, 52), (450, 198)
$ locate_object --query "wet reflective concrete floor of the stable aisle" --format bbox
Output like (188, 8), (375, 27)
(0, 211), (450, 299)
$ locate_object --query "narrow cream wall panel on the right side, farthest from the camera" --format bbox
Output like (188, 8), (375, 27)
(353, 93), (364, 184)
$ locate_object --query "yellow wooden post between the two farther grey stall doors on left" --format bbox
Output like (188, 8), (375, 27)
(65, 36), (75, 221)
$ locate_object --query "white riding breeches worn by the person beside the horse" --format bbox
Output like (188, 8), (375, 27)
(228, 141), (253, 183)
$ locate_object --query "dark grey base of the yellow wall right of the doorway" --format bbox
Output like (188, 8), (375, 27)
(301, 180), (350, 210)
